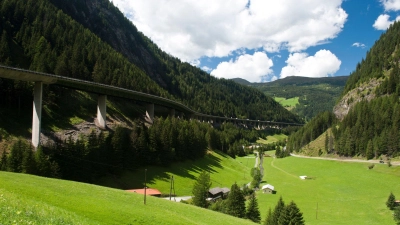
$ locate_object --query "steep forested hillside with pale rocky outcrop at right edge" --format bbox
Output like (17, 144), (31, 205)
(289, 22), (400, 159)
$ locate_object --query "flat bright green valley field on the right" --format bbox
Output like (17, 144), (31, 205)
(238, 154), (400, 224)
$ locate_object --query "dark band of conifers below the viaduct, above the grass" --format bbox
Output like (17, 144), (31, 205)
(0, 117), (276, 183)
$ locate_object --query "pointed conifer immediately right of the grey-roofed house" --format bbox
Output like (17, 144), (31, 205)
(226, 183), (246, 218)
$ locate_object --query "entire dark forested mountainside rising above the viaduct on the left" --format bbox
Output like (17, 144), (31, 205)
(9, 0), (300, 122)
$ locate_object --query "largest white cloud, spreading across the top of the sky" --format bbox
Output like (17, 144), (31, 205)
(113, 0), (347, 62)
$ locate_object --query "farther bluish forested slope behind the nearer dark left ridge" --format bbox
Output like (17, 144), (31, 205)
(44, 0), (299, 122)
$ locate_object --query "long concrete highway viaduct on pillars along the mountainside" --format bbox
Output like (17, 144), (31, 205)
(0, 65), (303, 148)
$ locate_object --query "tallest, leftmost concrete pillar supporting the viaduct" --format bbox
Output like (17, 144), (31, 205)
(32, 81), (43, 149)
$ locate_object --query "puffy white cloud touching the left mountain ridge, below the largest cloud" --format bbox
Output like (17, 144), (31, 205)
(211, 52), (274, 82)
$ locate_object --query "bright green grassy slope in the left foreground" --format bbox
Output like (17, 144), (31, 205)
(0, 172), (252, 224)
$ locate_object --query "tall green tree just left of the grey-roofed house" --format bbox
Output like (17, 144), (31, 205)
(192, 171), (211, 208)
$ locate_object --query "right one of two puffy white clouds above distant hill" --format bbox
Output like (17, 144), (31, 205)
(280, 49), (341, 79)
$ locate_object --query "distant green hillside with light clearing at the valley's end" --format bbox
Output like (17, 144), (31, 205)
(248, 76), (348, 120)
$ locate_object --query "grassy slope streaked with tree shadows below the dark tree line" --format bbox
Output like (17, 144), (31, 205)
(99, 152), (254, 196)
